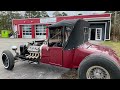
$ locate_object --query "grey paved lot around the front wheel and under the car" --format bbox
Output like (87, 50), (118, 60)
(0, 39), (69, 79)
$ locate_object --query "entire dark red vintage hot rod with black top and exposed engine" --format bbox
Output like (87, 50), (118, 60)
(2, 19), (120, 79)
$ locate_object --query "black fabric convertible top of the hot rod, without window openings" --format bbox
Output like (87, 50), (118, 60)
(49, 19), (90, 50)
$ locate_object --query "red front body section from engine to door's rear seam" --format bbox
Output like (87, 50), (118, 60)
(40, 45), (63, 66)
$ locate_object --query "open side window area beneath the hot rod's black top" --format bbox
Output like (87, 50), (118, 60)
(49, 27), (72, 46)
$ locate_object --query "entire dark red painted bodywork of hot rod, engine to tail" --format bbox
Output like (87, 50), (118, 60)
(40, 42), (120, 68)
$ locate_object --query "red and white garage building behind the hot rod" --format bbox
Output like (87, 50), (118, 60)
(12, 13), (111, 41)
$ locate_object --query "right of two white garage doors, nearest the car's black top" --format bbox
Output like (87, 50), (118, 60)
(35, 25), (46, 39)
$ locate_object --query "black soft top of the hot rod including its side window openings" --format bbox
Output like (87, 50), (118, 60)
(48, 19), (90, 50)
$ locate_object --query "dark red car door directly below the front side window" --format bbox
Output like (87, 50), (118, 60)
(49, 47), (63, 66)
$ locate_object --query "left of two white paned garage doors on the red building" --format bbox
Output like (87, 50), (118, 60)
(22, 25), (32, 38)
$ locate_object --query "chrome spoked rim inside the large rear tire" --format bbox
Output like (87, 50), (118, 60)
(86, 66), (110, 79)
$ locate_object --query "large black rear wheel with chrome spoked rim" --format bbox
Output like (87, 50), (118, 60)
(78, 55), (120, 79)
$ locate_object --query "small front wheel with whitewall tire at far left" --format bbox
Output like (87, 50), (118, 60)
(2, 50), (14, 70)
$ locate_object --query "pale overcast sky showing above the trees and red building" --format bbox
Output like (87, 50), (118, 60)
(21, 11), (105, 17)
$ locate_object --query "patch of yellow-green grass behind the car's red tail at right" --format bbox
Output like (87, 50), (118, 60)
(101, 41), (120, 57)
